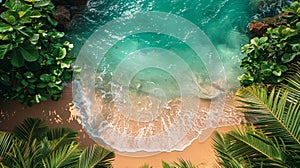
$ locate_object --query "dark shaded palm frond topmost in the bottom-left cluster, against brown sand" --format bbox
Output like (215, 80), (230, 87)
(13, 118), (48, 144)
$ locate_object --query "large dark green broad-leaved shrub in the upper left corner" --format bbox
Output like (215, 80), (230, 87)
(0, 0), (74, 105)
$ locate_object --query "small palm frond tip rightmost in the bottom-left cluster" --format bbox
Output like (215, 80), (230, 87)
(79, 145), (115, 168)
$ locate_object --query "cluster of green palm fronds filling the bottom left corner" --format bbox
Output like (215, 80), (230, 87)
(0, 118), (114, 168)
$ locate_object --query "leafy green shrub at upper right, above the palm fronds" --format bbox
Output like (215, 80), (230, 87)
(239, 2), (300, 86)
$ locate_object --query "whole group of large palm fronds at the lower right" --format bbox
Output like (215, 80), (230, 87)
(214, 62), (300, 168)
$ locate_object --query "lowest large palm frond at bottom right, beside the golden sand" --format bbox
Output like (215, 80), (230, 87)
(214, 125), (289, 168)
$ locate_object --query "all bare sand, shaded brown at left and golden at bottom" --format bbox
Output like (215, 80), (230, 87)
(0, 87), (239, 168)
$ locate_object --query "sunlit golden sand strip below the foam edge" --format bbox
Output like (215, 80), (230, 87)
(113, 126), (235, 168)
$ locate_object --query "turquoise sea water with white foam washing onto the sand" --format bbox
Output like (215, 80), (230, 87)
(68, 0), (276, 155)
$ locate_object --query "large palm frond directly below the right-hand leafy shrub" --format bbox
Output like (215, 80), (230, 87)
(236, 86), (300, 151)
